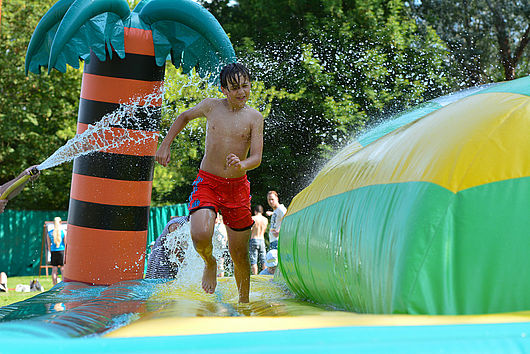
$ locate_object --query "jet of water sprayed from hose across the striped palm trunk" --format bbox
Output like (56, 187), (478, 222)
(37, 88), (164, 170)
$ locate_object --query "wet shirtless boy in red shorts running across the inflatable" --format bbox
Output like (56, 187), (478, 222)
(156, 63), (263, 302)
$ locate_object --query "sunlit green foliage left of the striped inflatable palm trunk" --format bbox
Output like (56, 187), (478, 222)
(0, 0), (81, 210)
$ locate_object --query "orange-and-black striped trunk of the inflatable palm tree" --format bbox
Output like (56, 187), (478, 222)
(65, 28), (164, 284)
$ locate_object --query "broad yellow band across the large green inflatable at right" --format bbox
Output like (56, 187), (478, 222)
(287, 93), (530, 215)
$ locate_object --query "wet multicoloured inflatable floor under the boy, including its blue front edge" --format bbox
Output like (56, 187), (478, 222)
(0, 276), (530, 353)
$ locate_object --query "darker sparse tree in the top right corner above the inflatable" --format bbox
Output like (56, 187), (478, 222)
(409, 0), (530, 83)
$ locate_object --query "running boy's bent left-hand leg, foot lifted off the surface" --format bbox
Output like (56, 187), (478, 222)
(190, 209), (217, 294)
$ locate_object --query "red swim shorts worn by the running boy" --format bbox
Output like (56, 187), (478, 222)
(188, 170), (254, 231)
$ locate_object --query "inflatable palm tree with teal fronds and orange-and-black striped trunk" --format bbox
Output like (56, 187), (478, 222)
(26, 0), (235, 284)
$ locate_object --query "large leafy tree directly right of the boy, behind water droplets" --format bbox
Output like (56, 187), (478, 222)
(200, 0), (456, 203)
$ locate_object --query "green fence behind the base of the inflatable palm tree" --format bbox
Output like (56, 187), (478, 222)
(0, 204), (188, 277)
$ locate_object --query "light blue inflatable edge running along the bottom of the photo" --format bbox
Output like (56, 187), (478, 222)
(0, 322), (530, 353)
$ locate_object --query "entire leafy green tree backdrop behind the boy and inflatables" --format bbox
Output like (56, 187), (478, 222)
(0, 0), (530, 210)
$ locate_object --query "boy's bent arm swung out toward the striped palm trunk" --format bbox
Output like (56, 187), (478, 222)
(156, 98), (212, 166)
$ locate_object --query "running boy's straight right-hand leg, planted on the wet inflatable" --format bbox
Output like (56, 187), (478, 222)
(226, 227), (251, 302)
